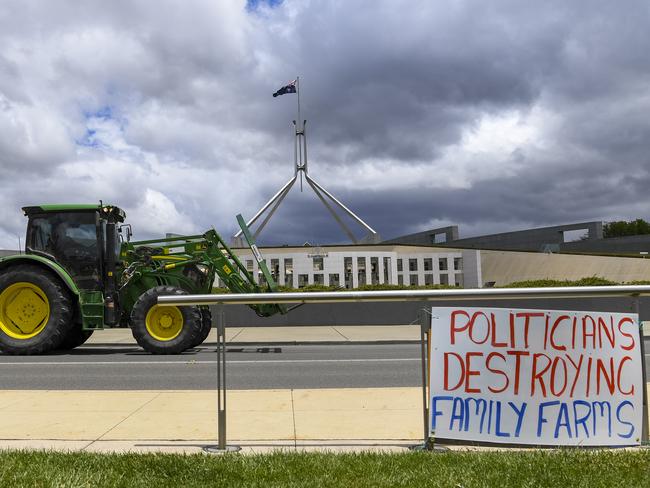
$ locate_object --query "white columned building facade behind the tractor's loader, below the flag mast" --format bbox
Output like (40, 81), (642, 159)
(219, 244), (482, 289)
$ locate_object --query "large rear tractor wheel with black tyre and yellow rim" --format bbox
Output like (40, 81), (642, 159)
(0, 264), (73, 355)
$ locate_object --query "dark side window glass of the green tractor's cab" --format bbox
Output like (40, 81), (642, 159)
(27, 212), (102, 289)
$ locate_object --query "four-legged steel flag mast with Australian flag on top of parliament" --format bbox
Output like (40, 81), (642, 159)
(233, 77), (381, 247)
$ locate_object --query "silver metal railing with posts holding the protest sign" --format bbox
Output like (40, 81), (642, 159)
(158, 285), (650, 452)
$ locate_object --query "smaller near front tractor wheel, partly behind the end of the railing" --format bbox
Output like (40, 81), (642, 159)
(131, 286), (202, 354)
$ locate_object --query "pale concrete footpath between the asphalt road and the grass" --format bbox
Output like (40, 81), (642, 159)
(0, 388), (422, 452)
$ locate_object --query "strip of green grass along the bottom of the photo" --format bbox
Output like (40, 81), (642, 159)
(0, 450), (650, 488)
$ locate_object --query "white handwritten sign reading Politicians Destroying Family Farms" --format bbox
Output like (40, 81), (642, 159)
(429, 307), (644, 446)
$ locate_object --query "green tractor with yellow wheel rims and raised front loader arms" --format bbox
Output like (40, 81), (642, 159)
(0, 202), (286, 355)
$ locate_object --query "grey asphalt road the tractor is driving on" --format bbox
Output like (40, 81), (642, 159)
(0, 338), (650, 390)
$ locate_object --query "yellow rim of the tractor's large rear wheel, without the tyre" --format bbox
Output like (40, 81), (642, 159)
(0, 281), (50, 340)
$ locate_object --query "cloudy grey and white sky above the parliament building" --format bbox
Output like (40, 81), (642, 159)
(0, 0), (650, 248)
